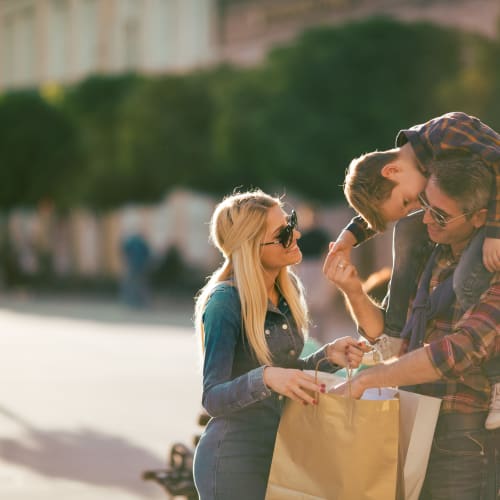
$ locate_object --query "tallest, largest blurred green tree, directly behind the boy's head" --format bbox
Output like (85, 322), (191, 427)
(216, 18), (462, 201)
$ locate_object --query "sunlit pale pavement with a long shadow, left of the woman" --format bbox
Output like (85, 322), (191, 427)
(0, 295), (201, 500)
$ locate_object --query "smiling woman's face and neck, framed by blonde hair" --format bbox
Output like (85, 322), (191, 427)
(260, 205), (302, 272)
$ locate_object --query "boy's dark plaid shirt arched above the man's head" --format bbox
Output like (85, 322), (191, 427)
(396, 112), (500, 238)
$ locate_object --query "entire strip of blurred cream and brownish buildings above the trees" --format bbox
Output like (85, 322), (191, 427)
(0, 0), (500, 91)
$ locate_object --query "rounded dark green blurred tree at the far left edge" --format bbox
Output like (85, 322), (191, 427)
(0, 91), (81, 209)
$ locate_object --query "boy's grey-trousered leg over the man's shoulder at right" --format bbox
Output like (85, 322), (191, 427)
(453, 228), (493, 310)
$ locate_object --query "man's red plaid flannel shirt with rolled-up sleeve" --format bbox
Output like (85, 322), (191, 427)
(410, 245), (500, 413)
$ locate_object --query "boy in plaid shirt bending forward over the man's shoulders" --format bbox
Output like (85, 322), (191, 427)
(331, 112), (500, 428)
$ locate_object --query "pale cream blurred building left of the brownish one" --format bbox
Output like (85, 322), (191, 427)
(0, 0), (215, 90)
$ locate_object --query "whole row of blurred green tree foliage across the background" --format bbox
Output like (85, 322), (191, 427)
(0, 18), (500, 208)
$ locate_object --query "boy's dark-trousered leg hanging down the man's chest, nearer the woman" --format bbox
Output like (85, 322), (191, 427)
(384, 212), (432, 337)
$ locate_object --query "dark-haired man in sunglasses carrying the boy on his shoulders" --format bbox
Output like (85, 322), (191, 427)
(325, 156), (500, 500)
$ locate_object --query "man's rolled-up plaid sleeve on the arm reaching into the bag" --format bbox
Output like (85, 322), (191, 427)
(427, 273), (500, 379)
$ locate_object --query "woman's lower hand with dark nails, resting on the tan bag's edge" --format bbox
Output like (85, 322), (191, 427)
(264, 366), (325, 405)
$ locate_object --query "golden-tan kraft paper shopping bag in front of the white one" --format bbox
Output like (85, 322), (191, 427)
(266, 380), (399, 500)
